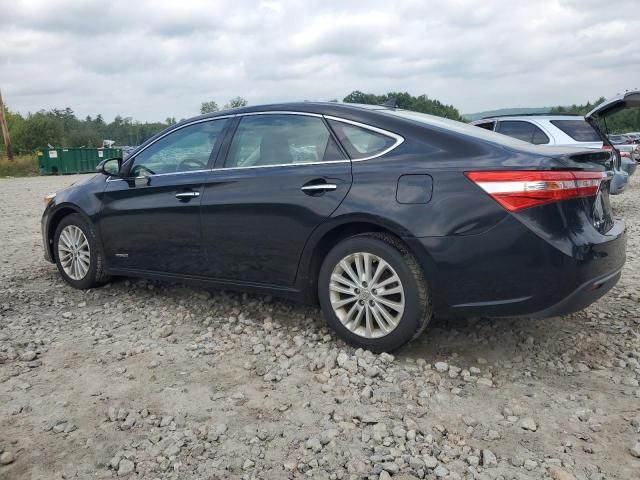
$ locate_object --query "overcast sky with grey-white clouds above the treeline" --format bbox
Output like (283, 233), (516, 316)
(0, 0), (640, 121)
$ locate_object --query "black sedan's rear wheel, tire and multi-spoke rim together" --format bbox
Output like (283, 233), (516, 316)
(318, 233), (432, 352)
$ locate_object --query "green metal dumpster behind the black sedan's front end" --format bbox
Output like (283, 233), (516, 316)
(38, 148), (122, 175)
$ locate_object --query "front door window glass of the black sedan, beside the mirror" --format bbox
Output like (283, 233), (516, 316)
(130, 119), (227, 177)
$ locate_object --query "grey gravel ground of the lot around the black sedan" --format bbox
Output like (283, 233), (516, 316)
(0, 175), (640, 480)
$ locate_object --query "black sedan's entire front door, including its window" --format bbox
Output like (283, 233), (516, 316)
(99, 119), (228, 274)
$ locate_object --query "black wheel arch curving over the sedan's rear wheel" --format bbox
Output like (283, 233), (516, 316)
(297, 215), (430, 305)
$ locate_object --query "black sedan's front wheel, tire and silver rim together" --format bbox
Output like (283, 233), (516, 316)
(53, 213), (109, 289)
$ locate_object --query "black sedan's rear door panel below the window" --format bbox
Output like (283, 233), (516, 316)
(201, 160), (351, 286)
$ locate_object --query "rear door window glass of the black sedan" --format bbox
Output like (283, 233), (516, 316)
(224, 114), (344, 168)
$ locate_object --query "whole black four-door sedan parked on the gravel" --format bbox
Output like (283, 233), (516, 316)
(42, 103), (626, 351)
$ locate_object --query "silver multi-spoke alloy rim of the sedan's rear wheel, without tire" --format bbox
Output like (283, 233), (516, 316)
(329, 252), (405, 338)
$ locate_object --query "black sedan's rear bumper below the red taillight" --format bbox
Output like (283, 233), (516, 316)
(405, 215), (626, 318)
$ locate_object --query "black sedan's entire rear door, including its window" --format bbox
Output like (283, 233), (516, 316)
(201, 113), (351, 286)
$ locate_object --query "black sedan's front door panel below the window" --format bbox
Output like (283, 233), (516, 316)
(100, 171), (209, 274)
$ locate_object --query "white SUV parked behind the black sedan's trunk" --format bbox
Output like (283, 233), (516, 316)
(471, 114), (630, 195)
